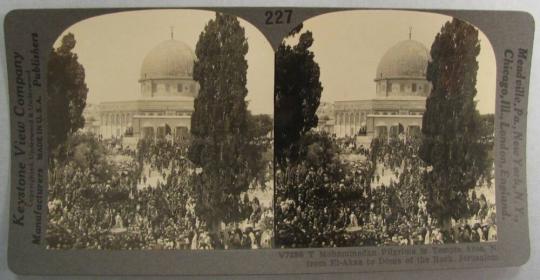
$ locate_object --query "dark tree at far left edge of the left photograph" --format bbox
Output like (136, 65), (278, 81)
(47, 33), (88, 161)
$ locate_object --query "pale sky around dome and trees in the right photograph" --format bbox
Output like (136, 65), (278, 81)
(287, 10), (496, 114)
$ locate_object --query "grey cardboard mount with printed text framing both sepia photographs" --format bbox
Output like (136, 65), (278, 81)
(4, 7), (534, 275)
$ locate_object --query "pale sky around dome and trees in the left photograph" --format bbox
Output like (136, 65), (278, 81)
(55, 10), (274, 114)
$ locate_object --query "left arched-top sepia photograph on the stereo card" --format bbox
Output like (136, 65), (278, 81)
(44, 10), (274, 250)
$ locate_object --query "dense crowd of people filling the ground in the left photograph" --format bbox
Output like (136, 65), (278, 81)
(47, 133), (273, 250)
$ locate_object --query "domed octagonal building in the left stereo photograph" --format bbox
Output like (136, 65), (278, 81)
(99, 38), (199, 140)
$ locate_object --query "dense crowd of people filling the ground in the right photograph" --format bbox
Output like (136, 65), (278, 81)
(275, 133), (497, 248)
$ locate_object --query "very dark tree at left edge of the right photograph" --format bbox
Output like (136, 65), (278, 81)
(274, 25), (323, 163)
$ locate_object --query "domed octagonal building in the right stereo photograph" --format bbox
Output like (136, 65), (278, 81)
(332, 39), (431, 140)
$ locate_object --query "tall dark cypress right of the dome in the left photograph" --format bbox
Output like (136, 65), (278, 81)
(188, 13), (264, 230)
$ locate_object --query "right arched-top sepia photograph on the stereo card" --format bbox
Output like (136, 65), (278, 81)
(274, 10), (497, 248)
